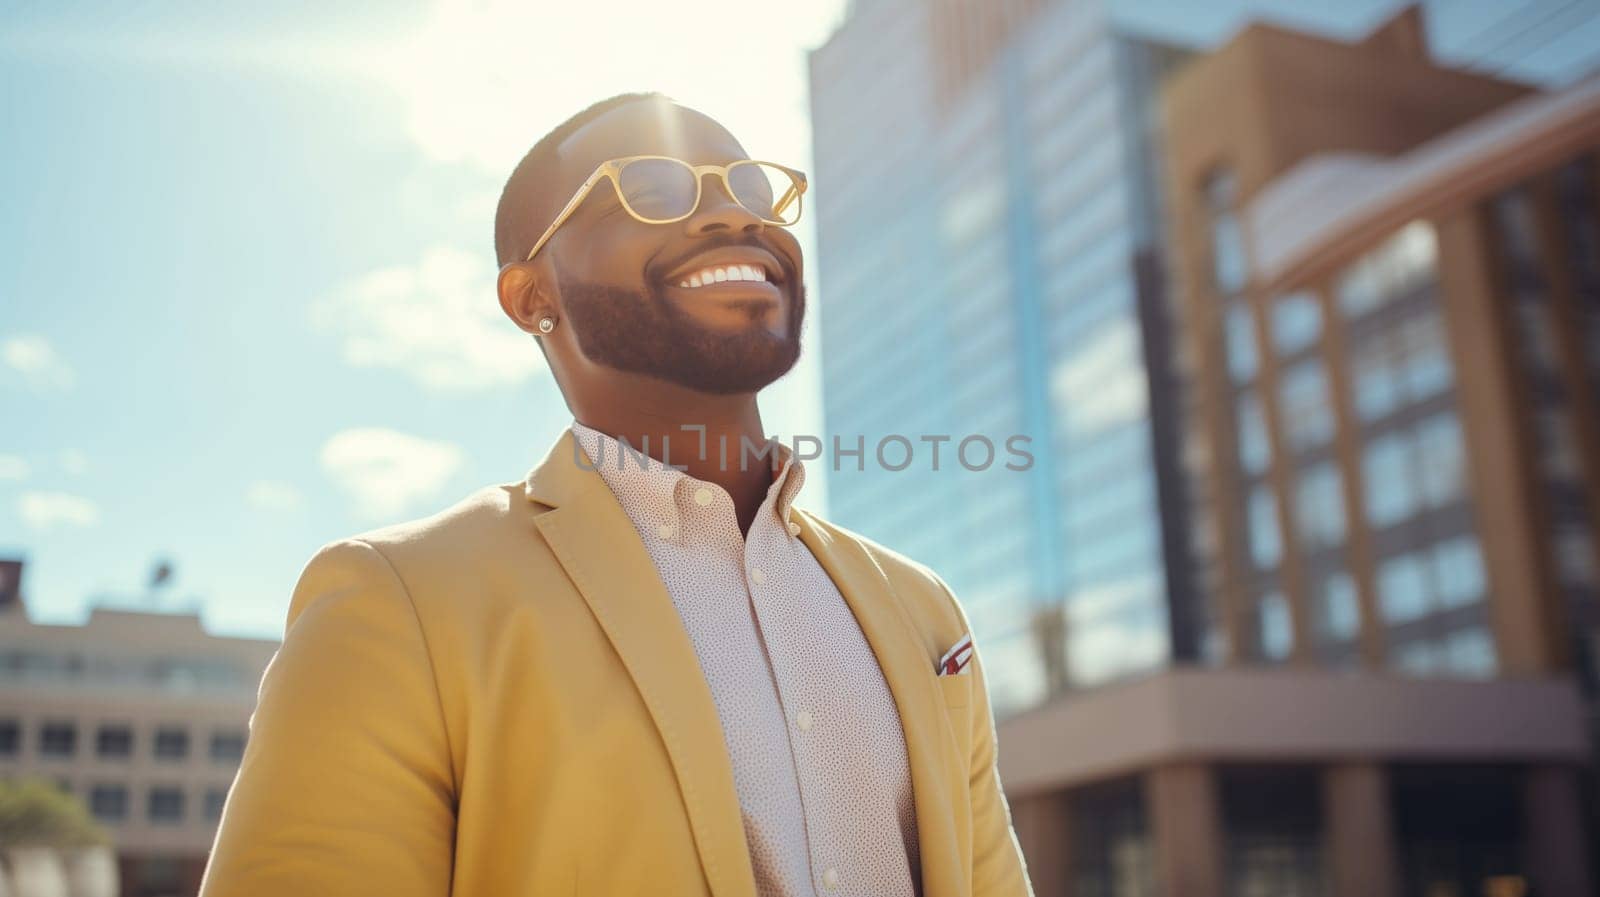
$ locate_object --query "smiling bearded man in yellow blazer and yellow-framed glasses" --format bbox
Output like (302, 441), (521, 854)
(202, 94), (1030, 897)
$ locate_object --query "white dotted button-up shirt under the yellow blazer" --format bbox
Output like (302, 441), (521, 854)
(573, 422), (922, 897)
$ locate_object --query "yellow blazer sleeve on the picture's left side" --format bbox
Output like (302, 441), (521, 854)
(200, 540), (454, 897)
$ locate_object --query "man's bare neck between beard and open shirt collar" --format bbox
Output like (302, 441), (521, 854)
(573, 381), (773, 532)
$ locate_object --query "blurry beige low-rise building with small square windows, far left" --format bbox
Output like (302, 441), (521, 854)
(0, 566), (278, 897)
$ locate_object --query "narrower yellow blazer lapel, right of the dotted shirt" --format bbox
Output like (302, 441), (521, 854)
(794, 508), (970, 897)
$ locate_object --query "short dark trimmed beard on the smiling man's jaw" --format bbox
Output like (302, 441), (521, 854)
(555, 264), (805, 395)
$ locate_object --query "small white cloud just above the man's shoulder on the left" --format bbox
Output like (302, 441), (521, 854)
(322, 427), (464, 518)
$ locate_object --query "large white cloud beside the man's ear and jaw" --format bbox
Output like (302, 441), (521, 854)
(314, 246), (544, 392)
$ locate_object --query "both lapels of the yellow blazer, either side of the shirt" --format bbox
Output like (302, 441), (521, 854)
(525, 430), (966, 897)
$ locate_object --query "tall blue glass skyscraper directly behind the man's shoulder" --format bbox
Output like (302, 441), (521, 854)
(811, 0), (1187, 713)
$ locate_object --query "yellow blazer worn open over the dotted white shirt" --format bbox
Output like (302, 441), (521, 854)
(200, 432), (1030, 897)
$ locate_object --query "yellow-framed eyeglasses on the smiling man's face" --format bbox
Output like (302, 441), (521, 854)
(528, 155), (806, 261)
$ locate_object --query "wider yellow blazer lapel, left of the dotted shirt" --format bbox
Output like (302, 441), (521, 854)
(526, 430), (755, 897)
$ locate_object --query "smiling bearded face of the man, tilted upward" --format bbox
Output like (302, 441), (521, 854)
(546, 101), (805, 395)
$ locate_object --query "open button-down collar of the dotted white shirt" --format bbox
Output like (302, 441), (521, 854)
(571, 421), (805, 536)
